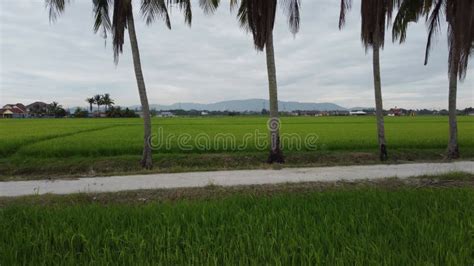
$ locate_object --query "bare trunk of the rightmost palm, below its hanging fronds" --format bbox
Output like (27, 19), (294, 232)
(448, 67), (459, 159)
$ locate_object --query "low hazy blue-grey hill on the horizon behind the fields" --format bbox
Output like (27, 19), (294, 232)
(131, 99), (347, 112)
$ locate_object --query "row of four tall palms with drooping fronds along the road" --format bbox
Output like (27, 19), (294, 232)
(45, 0), (474, 168)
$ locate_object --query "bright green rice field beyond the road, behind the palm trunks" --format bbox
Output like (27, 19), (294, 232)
(0, 116), (474, 178)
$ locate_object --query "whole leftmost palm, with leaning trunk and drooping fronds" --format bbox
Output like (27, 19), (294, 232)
(45, 0), (192, 169)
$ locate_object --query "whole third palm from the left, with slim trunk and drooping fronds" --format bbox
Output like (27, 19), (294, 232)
(339, 0), (398, 161)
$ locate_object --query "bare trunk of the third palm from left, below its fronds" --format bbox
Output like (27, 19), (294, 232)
(372, 45), (388, 161)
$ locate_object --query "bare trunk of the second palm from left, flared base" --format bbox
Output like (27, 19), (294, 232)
(265, 33), (285, 163)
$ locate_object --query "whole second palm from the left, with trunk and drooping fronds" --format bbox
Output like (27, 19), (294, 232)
(199, 0), (301, 163)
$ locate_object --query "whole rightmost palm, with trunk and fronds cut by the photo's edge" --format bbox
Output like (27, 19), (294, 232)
(392, 0), (474, 159)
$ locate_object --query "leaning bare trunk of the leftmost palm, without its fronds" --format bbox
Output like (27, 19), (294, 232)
(127, 11), (153, 169)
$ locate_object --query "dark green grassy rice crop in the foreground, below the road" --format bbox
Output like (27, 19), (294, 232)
(0, 173), (474, 265)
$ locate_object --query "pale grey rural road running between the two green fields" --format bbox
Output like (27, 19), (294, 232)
(0, 161), (474, 197)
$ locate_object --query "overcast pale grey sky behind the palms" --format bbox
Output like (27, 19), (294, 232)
(0, 0), (474, 108)
